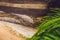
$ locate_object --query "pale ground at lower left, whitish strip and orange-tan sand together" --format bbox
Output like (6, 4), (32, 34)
(0, 21), (36, 40)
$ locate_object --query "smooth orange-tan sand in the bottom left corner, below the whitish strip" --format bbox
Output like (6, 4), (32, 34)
(0, 24), (20, 40)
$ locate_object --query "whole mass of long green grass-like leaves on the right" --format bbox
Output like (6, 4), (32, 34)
(30, 8), (60, 40)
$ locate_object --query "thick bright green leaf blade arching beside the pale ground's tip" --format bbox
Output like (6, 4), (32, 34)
(30, 18), (60, 40)
